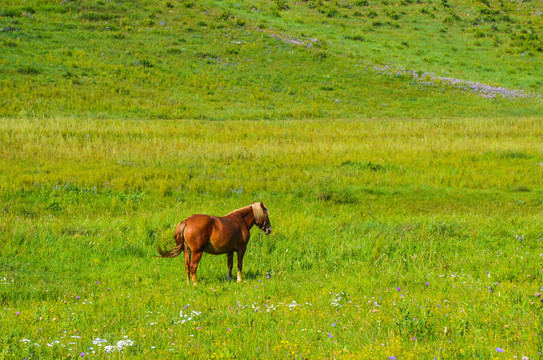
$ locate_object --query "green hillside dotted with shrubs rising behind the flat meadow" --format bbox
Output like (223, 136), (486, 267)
(0, 0), (543, 119)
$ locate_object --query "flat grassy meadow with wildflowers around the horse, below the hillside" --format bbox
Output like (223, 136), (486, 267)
(0, 118), (543, 359)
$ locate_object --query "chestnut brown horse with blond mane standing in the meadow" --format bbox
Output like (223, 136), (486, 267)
(158, 203), (272, 286)
